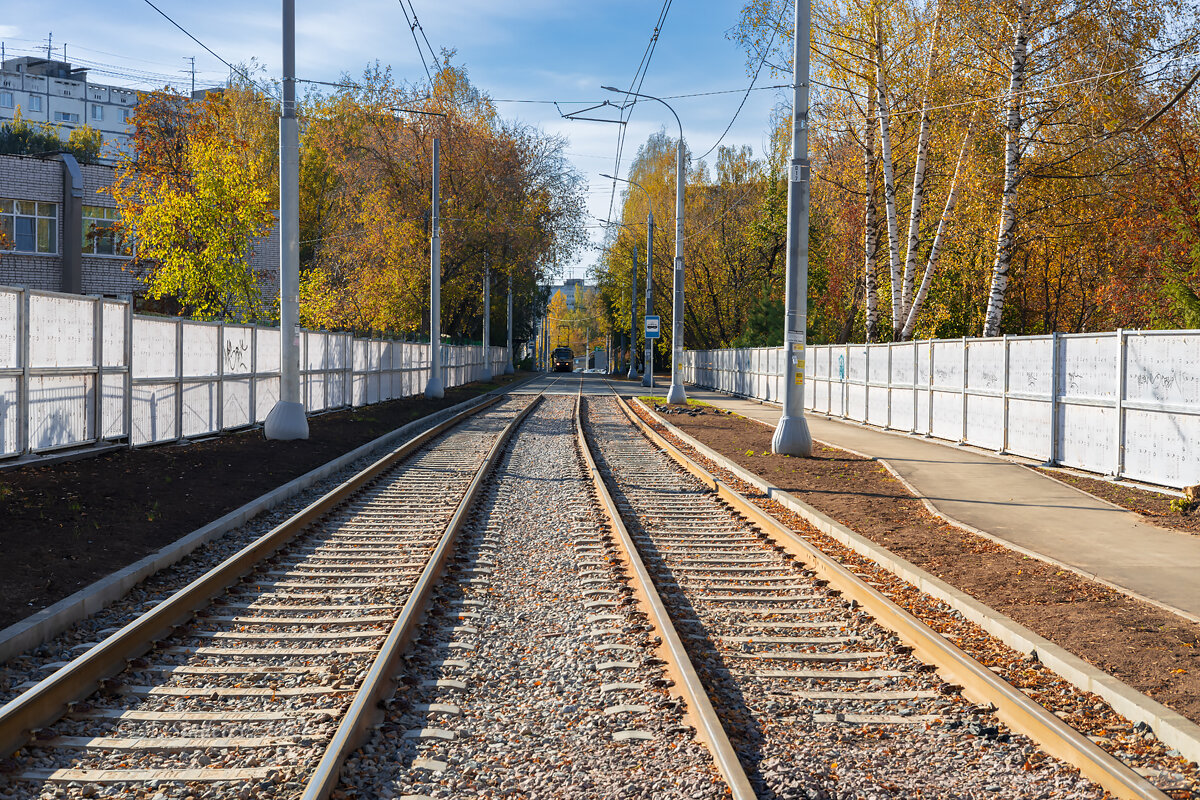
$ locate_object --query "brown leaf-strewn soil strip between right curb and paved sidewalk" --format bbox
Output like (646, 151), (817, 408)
(648, 408), (1200, 722)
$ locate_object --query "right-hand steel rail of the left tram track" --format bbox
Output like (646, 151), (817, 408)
(300, 393), (542, 800)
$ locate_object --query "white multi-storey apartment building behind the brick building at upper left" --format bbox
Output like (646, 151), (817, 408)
(0, 56), (138, 160)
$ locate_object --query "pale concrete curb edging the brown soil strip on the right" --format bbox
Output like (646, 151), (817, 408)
(635, 398), (1200, 762)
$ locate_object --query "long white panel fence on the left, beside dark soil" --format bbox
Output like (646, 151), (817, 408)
(0, 287), (508, 459)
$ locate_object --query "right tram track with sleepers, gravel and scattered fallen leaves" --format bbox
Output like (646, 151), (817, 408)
(586, 397), (1165, 798)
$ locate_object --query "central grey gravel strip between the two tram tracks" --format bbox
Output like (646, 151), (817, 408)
(341, 396), (728, 800)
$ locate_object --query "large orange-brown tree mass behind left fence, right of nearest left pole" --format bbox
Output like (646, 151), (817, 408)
(301, 54), (583, 338)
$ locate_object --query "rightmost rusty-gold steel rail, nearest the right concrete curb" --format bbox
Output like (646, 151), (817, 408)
(617, 397), (1169, 800)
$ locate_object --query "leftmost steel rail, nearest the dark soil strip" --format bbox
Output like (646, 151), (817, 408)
(0, 397), (500, 757)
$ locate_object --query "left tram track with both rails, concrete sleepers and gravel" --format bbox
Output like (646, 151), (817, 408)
(0, 397), (540, 798)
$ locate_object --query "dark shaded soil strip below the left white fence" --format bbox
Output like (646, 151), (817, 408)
(0, 375), (521, 627)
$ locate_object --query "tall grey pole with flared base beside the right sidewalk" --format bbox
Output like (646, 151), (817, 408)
(770, 0), (812, 457)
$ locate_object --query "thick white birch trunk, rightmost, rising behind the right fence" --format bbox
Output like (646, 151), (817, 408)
(983, 0), (1030, 336)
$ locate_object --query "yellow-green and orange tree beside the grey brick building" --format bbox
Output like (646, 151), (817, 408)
(110, 82), (278, 321)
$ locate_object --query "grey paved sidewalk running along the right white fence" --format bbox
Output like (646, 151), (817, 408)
(613, 381), (1200, 619)
